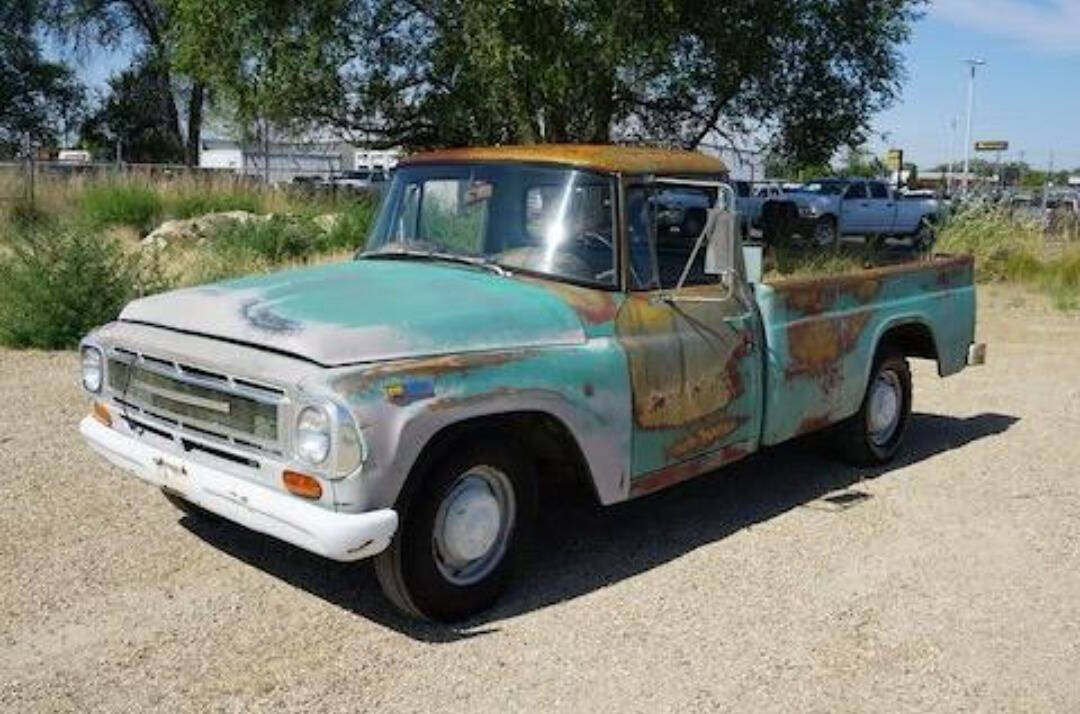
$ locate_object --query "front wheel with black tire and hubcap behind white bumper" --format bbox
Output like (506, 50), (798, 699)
(375, 432), (536, 621)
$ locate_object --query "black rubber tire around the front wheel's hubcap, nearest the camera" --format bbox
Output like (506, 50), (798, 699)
(375, 433), (537, 622)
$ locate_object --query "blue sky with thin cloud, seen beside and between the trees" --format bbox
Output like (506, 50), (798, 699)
(56, 0), (1080, 170)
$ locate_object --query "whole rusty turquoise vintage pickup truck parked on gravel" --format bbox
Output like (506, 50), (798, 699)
(80, 146), (983, 619)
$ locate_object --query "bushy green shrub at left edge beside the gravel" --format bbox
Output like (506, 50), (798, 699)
(0, 221), (166, 349)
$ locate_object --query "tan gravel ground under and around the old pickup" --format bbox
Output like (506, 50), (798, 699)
(0, 292), (1080, 712)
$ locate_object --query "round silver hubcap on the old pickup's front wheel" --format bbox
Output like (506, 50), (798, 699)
(432, 466), (514, 585)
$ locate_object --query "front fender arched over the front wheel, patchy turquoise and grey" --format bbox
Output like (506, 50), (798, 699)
(317, 337), (631, 510)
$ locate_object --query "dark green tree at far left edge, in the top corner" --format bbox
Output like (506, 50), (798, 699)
(0, 0), (85, 157)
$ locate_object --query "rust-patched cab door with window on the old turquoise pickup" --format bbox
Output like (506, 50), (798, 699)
(615, 183), (761, 496)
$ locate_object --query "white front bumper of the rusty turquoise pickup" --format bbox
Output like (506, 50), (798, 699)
(79, 417), (397, 561)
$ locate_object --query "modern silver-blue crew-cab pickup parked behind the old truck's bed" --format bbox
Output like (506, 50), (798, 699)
(770, 178), (941, 251)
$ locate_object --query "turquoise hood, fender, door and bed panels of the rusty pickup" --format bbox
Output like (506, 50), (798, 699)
(88, 245), (975, 508)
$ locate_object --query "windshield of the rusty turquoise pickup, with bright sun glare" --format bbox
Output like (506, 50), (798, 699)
(367, 163), (616, 286)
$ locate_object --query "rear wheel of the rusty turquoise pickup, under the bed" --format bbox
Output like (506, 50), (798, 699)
(836, 353), (912, 466)
